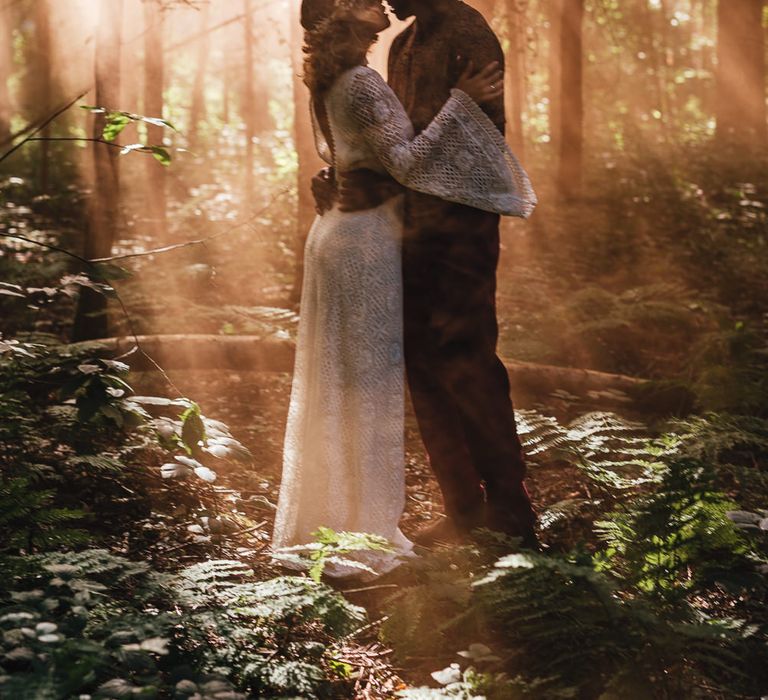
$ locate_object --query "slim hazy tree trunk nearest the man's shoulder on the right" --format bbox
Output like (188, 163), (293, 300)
(504, 0), (527, 158)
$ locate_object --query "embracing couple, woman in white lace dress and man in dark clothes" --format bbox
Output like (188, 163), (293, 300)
(272, 0), (536, 577)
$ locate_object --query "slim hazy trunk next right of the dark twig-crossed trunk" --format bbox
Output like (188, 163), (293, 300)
(143, 0), (168, 243)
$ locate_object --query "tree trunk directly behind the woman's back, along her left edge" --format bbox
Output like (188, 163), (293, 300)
(291, 0), (325, 303)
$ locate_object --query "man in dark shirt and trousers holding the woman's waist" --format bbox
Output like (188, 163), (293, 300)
(312, 0), (536, 546)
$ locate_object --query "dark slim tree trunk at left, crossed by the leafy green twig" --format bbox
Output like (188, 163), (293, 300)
(72, 0), (123, 340)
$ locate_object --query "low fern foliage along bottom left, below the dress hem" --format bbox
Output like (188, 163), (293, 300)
(0, 550), (363, 699)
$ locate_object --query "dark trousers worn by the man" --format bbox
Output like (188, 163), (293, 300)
(403, 191), (535, 535)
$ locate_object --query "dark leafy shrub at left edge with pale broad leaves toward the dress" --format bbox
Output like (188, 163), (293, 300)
(0, 340), (251, 554)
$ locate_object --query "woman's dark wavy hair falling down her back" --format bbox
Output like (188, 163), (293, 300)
(301, 0), (376, 95)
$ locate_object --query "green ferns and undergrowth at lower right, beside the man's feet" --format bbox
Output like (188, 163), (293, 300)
(381, 413), (768, 700)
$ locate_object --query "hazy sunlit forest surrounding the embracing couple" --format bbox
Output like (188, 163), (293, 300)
(0, 0), (768, 700)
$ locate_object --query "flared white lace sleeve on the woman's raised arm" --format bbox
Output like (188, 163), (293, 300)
(347, 68), (536, 218)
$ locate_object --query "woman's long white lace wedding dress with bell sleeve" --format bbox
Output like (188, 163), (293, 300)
(272, 66), (536, 576)
